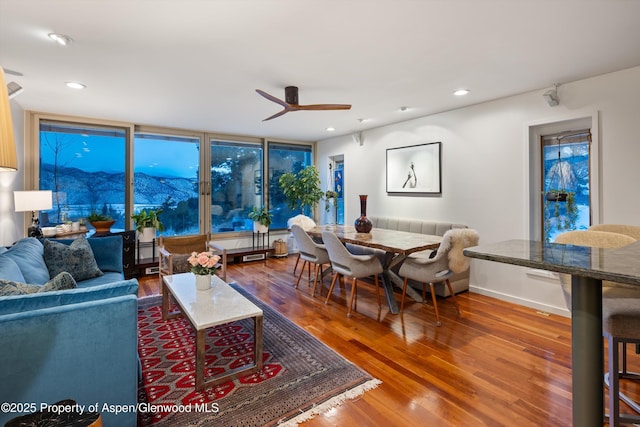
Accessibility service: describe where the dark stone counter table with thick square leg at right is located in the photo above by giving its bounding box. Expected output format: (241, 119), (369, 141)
(464, 240), (640, 427)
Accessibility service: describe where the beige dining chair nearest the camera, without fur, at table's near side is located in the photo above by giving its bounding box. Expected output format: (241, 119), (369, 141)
(322, 231), (383, 317)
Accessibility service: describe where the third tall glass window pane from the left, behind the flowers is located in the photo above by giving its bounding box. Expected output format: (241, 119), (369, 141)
(210, 140), (263, 232)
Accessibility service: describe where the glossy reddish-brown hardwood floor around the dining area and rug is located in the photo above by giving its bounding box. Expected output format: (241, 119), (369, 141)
(140, 256), (640, 427)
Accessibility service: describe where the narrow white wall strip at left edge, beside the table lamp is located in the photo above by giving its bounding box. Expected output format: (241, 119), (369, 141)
(0, 100), (27, 246)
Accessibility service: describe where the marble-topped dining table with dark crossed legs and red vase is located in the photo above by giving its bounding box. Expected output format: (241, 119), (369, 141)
(307, 224), (442, 314)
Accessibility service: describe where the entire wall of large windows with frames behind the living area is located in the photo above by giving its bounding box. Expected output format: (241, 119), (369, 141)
(30, 112), (313, 237)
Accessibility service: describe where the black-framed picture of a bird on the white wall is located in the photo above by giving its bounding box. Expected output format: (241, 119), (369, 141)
(387, 142), (442, 195)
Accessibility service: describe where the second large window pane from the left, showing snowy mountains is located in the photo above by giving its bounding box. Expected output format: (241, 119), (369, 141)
(133, 132), (200, 236)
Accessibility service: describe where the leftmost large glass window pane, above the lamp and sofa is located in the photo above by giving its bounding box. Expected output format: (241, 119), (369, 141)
(38, 120), (127, 230)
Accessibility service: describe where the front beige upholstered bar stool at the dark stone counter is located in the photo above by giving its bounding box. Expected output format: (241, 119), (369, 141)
(555, 230), (640, 426)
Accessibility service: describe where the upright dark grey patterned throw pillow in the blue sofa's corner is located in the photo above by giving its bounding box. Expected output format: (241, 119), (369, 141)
(44, 236), (104, 282)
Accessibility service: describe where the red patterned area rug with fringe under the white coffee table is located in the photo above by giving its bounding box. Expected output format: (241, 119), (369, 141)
(138, 285), (380, 427)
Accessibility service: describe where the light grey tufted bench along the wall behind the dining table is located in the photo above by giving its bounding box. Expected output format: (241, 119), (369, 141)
(356, 217), (469, 297)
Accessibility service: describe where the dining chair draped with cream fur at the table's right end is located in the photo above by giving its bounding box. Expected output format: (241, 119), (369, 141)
(398, 228), (480, 326)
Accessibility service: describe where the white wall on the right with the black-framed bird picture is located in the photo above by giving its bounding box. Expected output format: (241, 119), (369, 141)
(317, 67), (640, 315)
